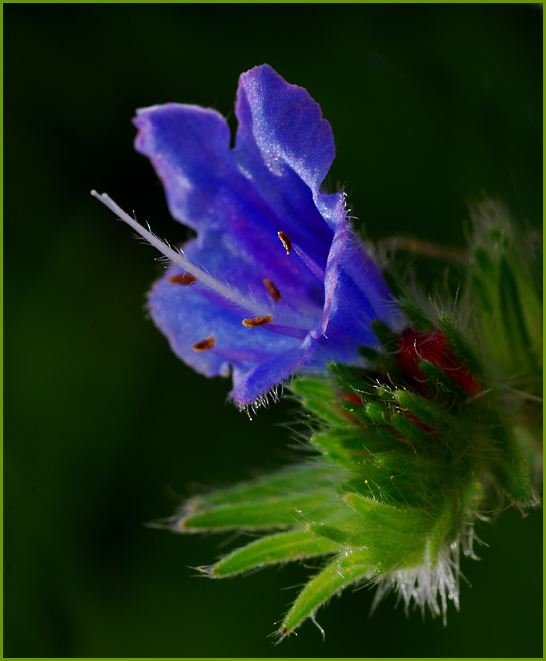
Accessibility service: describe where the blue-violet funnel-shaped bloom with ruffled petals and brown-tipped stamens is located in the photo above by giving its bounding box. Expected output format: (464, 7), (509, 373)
(134, 65), (396, 405)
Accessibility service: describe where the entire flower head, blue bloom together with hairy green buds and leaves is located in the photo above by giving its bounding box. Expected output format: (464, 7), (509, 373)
(93, 65), (542, 638)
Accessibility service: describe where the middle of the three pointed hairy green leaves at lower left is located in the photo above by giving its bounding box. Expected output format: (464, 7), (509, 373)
(207, 530), (339, 578)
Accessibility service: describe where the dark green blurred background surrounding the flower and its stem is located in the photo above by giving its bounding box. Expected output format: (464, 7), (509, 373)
(4, 4), (542, 657)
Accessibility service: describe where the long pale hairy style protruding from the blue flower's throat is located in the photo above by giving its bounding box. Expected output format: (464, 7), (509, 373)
(91, 190), (272, 317)
